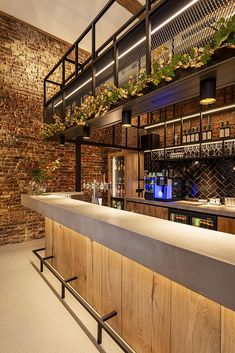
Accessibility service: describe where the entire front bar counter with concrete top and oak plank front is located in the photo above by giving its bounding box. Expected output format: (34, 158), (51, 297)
(22, 195), (235, 353)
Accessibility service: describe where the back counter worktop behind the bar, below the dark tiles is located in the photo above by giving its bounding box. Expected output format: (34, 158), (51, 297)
(125, 197), (235, 218)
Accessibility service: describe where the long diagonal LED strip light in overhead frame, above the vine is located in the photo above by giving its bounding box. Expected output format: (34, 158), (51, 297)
(54, 0), (199, 108)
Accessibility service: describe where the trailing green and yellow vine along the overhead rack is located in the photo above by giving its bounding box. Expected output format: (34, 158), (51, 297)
(43, 15), (235, 138)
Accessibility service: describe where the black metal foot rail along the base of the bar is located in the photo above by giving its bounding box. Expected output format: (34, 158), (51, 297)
(33, 248), (135, 353)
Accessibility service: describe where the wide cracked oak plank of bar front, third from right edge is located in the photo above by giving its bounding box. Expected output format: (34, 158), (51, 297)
(122, 257), (171, 353)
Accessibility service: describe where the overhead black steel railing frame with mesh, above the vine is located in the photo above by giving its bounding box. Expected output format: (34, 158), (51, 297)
(44, 0), (234, 122)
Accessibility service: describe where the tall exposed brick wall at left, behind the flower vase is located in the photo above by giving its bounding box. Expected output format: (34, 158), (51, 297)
(0, 13), (90, 245)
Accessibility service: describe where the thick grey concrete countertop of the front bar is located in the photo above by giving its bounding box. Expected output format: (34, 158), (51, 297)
(21, 195), (235, 310)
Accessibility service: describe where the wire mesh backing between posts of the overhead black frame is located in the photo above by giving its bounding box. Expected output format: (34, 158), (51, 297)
(46, 0), (234, 124)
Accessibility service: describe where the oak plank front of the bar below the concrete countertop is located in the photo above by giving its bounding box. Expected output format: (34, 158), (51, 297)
(45, 218), (235, 353)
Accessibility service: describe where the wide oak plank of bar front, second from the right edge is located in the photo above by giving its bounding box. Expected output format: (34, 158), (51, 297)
(171, 282), (220, 353)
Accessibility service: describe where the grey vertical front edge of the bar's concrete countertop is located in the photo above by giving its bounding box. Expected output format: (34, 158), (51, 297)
(21, 195), (235, 311)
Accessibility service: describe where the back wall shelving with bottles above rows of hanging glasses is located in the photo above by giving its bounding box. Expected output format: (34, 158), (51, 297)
(145, 100), (235, 160)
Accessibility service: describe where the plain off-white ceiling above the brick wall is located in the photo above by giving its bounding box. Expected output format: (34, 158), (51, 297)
(0, 0), (136, 52)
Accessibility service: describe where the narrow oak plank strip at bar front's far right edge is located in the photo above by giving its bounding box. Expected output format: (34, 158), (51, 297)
(221, 306), (235, 353)
